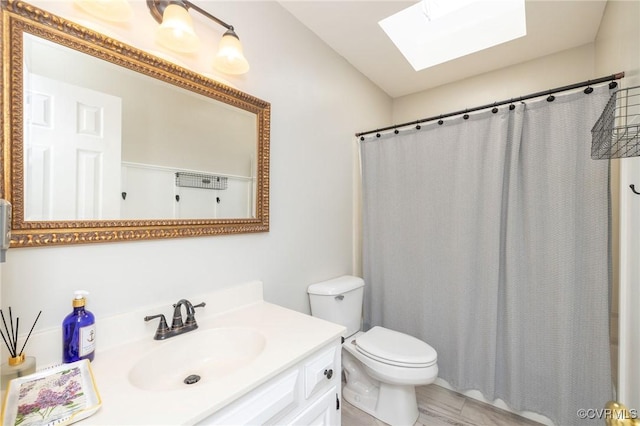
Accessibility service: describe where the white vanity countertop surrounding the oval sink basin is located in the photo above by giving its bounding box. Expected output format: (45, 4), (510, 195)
(86, 301), (344, 425)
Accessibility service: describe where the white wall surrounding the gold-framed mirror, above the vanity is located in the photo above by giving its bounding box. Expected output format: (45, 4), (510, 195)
(1, 0), (391, 351)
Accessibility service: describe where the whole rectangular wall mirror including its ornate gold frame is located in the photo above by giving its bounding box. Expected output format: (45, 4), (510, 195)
(0, 0), (271, 247)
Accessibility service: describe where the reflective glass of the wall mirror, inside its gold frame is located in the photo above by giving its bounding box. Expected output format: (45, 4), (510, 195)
(23, 34), (258, 221)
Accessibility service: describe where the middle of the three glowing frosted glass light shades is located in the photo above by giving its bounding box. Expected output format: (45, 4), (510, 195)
(156, 4), (200, 53)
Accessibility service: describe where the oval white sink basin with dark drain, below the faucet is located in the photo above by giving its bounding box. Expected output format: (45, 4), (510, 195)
(129, 328), (266, 391)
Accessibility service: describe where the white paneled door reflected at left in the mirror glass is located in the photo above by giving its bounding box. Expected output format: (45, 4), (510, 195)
(24, 74), (122, 221)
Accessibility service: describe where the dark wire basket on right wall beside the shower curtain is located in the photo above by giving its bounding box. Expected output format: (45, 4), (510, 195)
(591, 86), (640, 160)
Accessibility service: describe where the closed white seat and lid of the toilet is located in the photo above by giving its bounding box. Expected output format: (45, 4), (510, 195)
(355, 327), (438, 368)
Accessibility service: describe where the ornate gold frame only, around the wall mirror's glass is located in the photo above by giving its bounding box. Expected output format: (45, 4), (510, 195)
(0, 0), (271, 247)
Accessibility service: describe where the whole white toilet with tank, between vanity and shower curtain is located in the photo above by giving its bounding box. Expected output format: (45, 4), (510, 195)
(307, 275), (438, 426)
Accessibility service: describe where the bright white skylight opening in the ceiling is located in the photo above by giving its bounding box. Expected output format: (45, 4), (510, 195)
(378, 0), (527, 71)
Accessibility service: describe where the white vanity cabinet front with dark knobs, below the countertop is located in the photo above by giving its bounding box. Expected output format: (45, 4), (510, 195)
(198, 340), (342, 426)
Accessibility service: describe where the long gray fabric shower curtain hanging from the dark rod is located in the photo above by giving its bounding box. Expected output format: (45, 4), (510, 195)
(360, 86), (612, 425)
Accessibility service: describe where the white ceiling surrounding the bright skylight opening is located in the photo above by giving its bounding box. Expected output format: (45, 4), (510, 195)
(280, 0), (606, 98)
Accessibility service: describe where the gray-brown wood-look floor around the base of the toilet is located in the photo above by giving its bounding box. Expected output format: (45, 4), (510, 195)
(342, 385), (540, 426)
